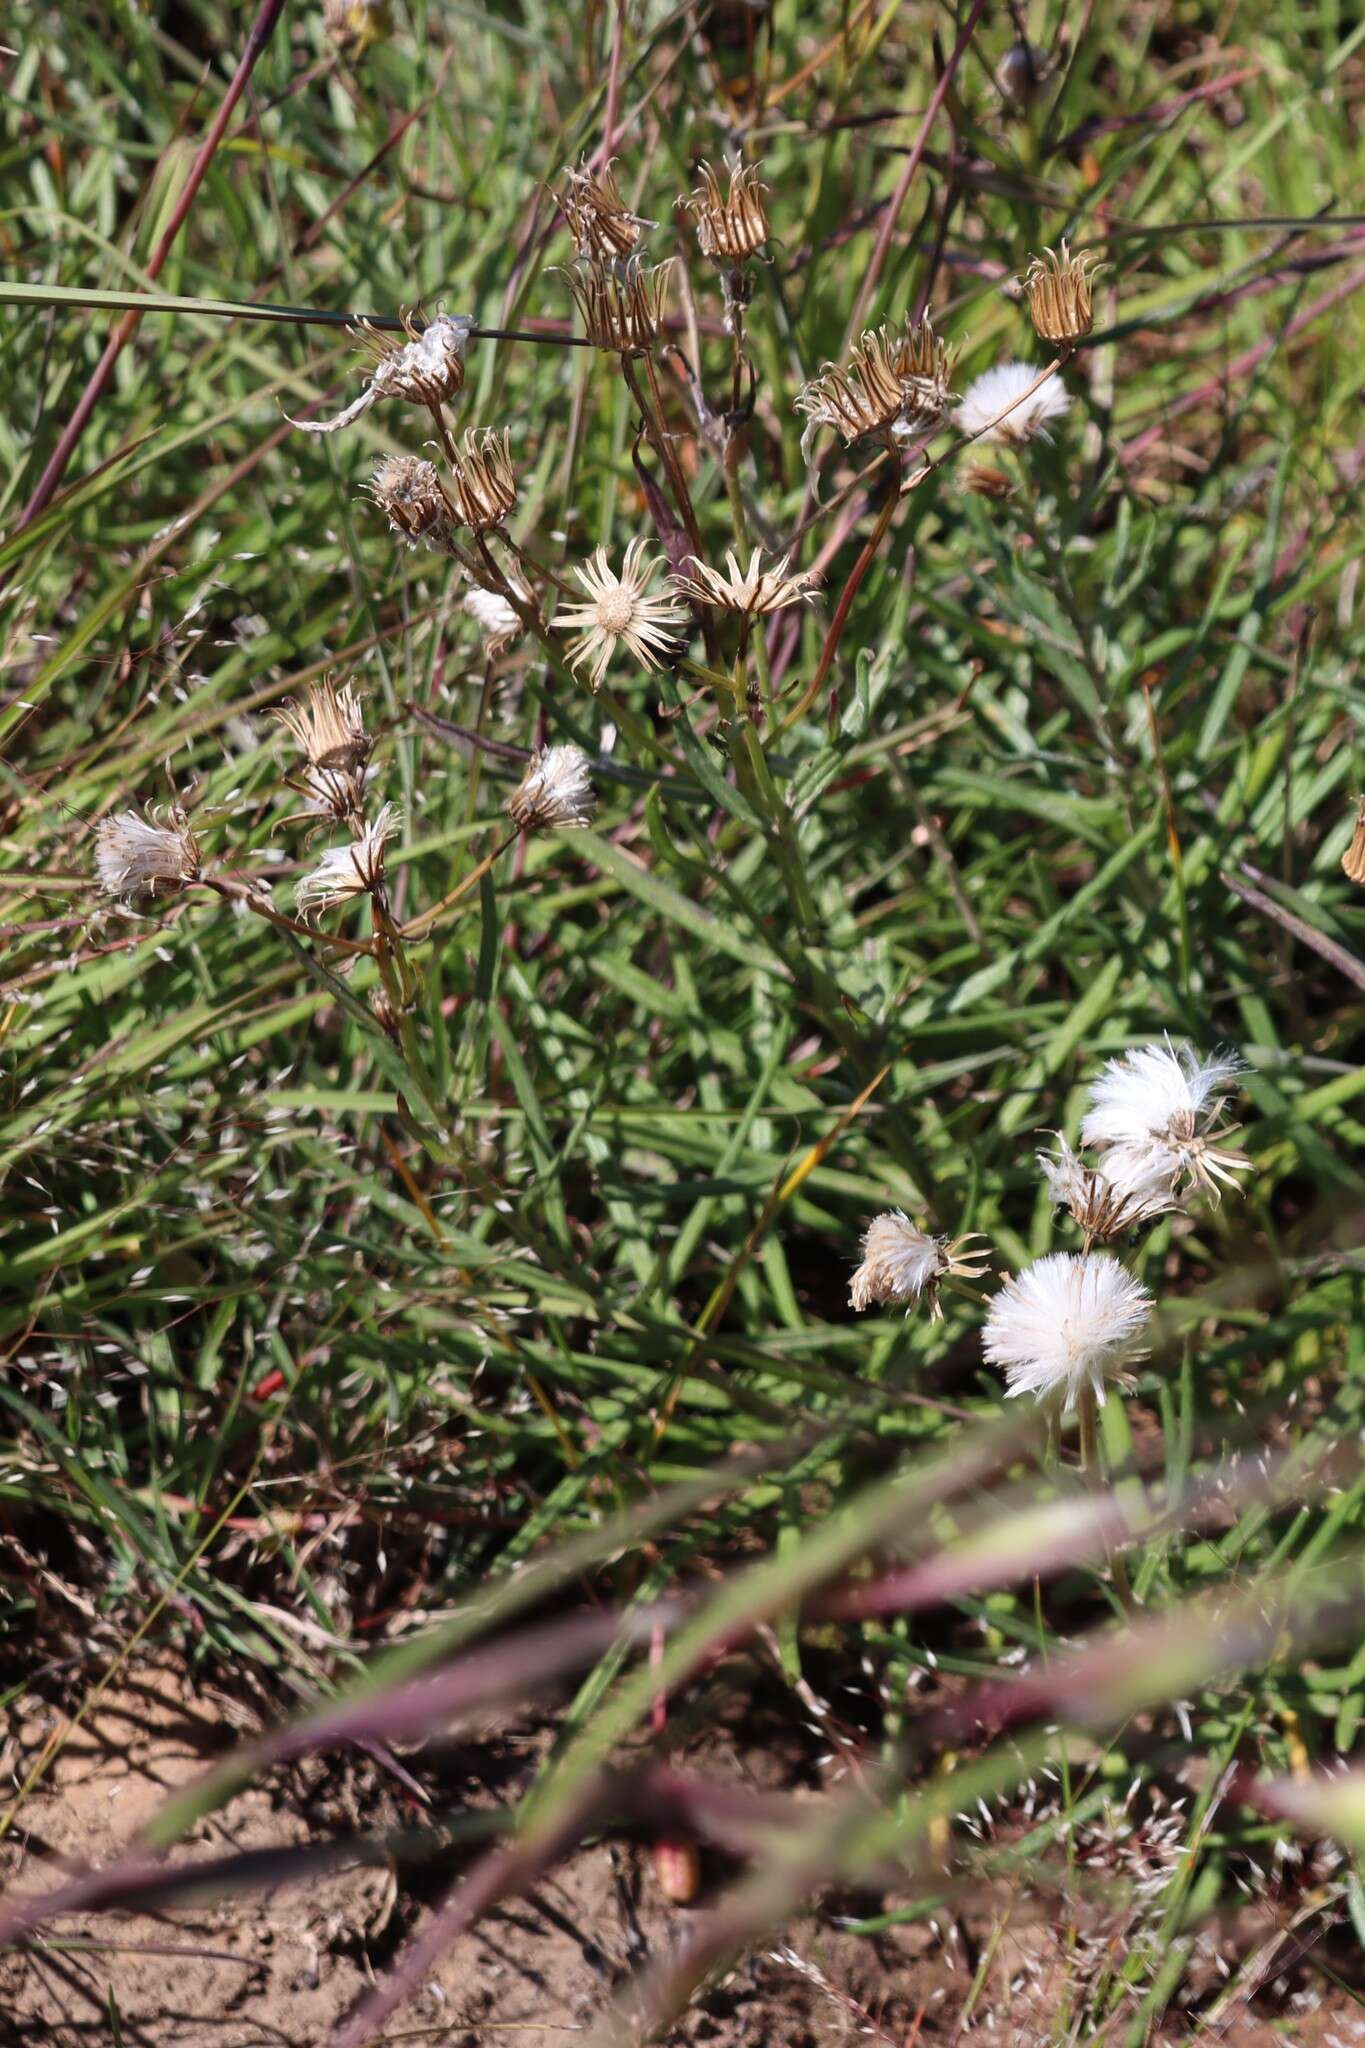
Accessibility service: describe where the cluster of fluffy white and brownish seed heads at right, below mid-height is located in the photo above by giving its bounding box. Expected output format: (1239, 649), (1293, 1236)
(849, 1040), (1248, 1468)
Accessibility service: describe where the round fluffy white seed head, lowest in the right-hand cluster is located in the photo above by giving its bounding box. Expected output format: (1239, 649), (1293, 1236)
(982, 1251), (1152, 1413)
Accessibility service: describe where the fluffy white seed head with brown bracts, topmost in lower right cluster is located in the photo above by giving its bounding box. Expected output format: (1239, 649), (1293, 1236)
(1081, 1038), (1250, 1200)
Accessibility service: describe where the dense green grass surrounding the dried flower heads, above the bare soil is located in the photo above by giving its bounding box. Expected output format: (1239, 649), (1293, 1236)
(0, 0), (1365, 2040)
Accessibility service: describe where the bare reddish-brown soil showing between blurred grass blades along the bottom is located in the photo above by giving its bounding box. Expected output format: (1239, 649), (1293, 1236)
(0, 1659), (1365, 2048)
